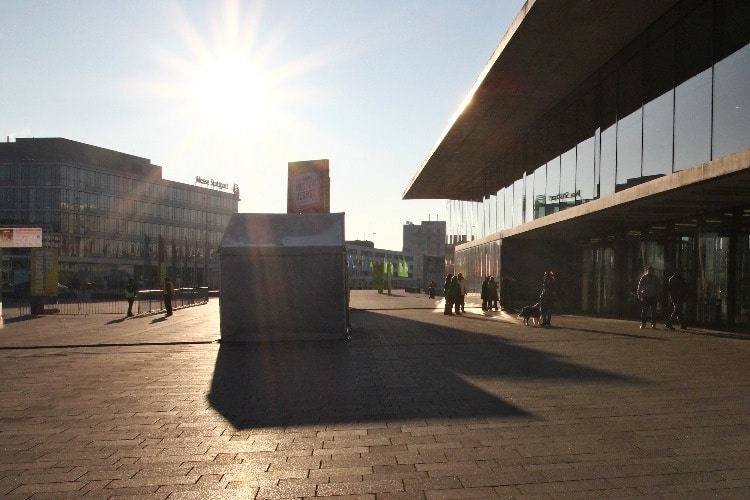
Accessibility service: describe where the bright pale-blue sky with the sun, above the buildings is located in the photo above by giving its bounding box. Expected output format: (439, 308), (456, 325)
(0, 0), (524, 250)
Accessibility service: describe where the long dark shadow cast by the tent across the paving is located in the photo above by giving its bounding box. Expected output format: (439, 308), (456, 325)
(208, 311), (643, 429)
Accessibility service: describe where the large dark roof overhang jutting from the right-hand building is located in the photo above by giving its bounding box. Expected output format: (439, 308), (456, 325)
(403, 0), (677, 201)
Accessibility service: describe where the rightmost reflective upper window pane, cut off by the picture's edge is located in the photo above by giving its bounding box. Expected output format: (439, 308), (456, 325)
(713, 45), (750, 158)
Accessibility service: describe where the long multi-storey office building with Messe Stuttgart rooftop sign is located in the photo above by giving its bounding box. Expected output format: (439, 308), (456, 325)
(0, 138), (239, 290)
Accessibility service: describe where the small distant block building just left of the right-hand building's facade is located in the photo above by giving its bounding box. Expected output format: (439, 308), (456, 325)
(404, 221), (447, 290)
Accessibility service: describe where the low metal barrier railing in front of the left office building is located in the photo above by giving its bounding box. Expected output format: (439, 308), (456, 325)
(2, 288), (208, 319)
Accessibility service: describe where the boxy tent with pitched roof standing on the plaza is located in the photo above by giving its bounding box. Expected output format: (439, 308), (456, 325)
(219, 213), (349, 342)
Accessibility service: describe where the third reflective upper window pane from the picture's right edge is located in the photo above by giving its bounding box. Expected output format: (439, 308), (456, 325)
(643, 91), (674, 177)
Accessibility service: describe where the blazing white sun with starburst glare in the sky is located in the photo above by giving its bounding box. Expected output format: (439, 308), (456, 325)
(141, 0), (314, 141)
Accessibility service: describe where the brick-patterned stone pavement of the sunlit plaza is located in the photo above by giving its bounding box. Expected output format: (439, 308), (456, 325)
(0, 291), (750, 500)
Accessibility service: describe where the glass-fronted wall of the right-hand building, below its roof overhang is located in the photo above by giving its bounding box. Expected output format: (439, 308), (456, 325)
(412, 0), (750, 326)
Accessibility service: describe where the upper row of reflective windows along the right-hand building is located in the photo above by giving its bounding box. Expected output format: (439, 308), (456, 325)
(449, 10), (750, 236)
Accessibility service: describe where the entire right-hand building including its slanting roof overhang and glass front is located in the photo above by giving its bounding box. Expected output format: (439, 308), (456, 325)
(404, 0), (750, 326)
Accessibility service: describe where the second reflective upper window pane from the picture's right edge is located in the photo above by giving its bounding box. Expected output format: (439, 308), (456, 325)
(674, 69), (711, 172)
